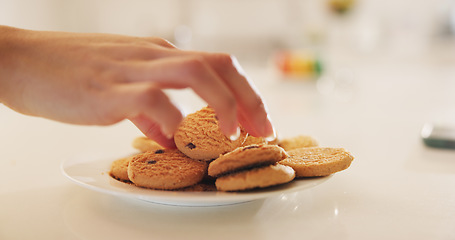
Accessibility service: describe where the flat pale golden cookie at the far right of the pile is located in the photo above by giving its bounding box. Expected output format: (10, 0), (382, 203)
(279, 147), (354, 177)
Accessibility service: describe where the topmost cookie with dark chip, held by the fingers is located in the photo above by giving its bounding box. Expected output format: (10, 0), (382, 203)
(174, 107), (247, 161)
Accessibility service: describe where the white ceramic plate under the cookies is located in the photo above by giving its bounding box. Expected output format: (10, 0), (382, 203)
(61, 156), (330, 206)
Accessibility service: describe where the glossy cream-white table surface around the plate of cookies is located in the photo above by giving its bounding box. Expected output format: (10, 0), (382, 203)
(0, 49), (455, 239)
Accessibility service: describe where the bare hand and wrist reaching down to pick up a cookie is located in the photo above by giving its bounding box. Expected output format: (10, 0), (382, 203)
(0, 26), (275, 147)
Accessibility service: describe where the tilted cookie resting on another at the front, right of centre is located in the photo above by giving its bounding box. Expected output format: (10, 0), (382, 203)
(208, 144), (288, 177)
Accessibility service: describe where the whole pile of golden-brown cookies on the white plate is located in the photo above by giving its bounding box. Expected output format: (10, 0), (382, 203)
(110, 107), (353, 191)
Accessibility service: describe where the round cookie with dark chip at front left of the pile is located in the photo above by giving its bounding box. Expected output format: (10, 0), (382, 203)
(128, 149), (207, 190)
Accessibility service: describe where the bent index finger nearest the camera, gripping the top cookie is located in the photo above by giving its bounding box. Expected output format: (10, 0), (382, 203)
(121, 56), (242, 138)
